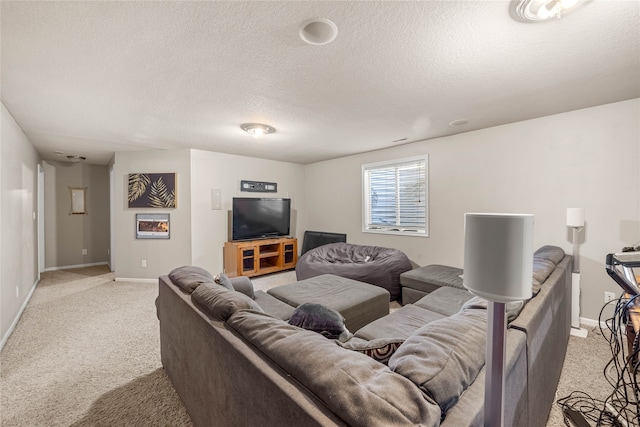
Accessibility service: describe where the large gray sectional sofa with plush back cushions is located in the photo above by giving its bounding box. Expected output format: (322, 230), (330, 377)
(156, 247), (571, 427)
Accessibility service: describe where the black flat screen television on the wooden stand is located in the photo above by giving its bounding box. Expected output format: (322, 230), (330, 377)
(231, 197), (291, 241)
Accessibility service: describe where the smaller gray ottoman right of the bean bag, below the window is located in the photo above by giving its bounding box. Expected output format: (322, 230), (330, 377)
(400, 264), (464, 304)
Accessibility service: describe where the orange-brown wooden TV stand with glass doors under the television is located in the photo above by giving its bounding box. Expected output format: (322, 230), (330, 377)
(224, 237), (298, 277)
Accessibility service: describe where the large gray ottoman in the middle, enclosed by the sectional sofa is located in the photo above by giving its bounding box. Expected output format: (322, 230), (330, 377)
(267, 274), (389, 332)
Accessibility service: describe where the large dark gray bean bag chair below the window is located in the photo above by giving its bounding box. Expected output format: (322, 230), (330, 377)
(296, 243), (412, 301)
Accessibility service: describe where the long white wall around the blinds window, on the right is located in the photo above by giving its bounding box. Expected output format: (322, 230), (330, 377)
(305, 99), (640, 319)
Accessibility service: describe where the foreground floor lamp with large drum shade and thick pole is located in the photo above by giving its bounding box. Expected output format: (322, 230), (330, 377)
(463, 213), (533, 427)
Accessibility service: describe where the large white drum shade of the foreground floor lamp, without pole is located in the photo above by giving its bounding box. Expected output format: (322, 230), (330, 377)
(464, 213), (533, 302)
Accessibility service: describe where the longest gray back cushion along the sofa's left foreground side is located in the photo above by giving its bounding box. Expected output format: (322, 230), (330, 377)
(227, 310), (441, 427)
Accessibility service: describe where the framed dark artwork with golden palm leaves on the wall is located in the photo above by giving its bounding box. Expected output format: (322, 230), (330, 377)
(127, 173), (177, 209)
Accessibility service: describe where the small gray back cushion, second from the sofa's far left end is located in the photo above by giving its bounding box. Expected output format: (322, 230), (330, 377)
(191, 283), (263, 322)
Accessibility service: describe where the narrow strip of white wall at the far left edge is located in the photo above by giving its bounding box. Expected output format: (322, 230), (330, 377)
(0, 104), (40, 348)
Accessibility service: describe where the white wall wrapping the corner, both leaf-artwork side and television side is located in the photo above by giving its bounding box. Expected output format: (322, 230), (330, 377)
(114, 150), (304, 279)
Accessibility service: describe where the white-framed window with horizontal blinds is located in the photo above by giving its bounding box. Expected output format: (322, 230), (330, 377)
(362, 155), (429, 237)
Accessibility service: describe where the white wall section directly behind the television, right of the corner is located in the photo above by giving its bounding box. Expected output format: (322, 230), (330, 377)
(191, 150), (304, 274)
